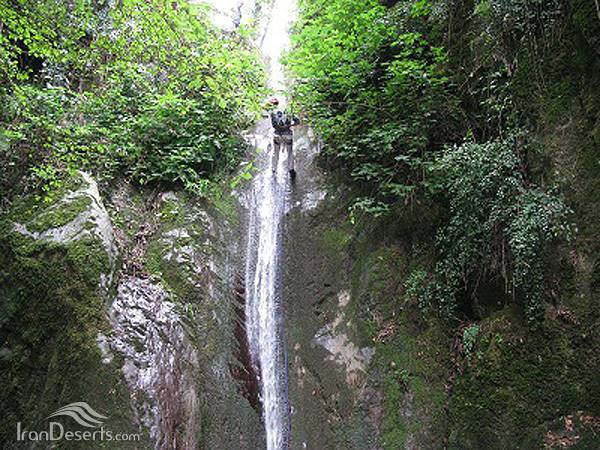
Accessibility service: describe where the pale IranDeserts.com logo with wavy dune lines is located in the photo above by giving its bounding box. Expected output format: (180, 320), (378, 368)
(17, 402), (140, 442)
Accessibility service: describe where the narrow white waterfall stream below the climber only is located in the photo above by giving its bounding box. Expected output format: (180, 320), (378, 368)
(246, 128), (289, 450)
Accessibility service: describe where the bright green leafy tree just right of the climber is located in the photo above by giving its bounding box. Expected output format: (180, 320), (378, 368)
(287, 0), (458, 214)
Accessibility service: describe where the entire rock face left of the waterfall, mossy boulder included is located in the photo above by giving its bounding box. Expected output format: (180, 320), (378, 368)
(0, 174), (263, 449)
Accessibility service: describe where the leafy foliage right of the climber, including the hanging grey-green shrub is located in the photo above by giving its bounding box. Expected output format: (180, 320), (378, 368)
(287, 0), (569, 322)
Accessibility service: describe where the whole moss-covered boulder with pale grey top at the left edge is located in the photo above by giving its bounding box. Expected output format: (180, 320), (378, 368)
(0, 173), (145, 448)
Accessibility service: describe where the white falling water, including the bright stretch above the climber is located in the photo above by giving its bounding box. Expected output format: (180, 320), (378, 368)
(246, 0), (294, 450)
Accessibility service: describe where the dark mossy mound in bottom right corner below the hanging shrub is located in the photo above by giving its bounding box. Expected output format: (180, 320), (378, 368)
(449, 309), (600, 449)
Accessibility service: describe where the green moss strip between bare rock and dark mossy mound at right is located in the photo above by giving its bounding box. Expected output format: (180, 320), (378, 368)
(351, 240), (449, 449)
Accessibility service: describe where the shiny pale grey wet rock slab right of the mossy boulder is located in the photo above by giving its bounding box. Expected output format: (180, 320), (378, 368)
(99, 277), (200, 448)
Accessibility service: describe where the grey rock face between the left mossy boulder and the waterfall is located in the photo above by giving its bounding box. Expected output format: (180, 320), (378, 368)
(105, 185), (262, 449)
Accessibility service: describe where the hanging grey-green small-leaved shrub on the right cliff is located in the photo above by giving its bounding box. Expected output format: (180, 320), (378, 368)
(421, 138), (570, 322)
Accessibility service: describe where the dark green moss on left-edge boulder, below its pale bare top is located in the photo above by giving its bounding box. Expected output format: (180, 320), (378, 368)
(0, 207), (142, 448)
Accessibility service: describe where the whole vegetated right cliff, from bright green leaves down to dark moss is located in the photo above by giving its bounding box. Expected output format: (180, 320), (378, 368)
(286, 0), (600, 448)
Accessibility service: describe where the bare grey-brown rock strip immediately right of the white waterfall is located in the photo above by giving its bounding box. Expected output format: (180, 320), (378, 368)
(283, 124), (381, 449)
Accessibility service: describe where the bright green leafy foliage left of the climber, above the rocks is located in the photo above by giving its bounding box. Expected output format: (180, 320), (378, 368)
(0, 0), (264, 200)
